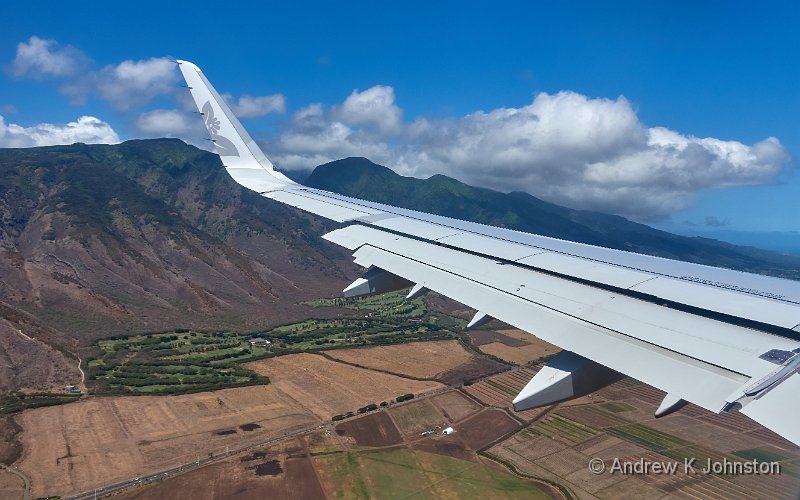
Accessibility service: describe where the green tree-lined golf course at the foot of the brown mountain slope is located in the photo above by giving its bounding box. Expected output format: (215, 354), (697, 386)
(87, 291), (461, 394)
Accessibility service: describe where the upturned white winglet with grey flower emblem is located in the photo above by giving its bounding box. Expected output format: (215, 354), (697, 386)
(177, 60), (296, 193)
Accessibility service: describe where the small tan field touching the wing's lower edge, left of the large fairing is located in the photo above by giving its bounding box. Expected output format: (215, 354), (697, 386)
(467, 329), (561, 365)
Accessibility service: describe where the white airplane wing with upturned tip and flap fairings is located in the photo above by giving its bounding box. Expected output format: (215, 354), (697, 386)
(178, 61), (800, 444)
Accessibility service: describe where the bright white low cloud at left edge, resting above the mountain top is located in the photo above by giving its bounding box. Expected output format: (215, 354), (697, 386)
(0, 116), (119, 148)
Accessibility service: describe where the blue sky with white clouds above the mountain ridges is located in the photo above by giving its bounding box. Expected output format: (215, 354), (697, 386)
(0, 1), (800, 240)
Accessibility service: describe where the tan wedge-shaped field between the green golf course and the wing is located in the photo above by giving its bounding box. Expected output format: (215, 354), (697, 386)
(326, 340), (475, 379)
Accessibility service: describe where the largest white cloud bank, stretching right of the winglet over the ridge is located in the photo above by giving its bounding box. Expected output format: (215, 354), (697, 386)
(266, 86), (790, 220)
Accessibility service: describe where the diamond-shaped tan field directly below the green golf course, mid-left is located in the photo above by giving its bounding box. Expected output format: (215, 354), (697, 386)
(244, 353), (444, 420)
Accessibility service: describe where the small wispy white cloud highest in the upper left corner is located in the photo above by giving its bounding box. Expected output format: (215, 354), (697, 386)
(8, 36), (89, 79)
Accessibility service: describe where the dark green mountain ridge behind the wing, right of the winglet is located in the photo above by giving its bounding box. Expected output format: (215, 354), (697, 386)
(306, 158), (800, 279)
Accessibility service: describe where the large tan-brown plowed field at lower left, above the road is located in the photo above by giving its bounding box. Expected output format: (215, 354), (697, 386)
(18, 385), (316, 497)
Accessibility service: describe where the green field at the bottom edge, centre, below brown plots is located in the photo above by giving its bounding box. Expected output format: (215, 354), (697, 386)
(315, 449), (550, 499)
